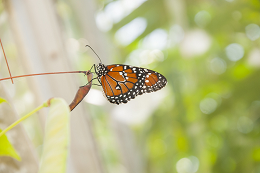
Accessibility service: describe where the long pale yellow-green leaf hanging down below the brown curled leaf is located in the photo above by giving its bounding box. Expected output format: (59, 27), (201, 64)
(39, 98), (70, 173)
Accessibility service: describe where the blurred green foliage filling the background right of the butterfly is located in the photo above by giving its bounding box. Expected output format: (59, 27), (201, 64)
(93, 0), (260, 173)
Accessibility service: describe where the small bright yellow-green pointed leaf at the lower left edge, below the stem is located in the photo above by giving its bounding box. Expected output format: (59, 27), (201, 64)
(0, 129), (21, 161)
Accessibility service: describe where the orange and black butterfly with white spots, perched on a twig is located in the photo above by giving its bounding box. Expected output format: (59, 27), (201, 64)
(88, 46), (167, 105)
